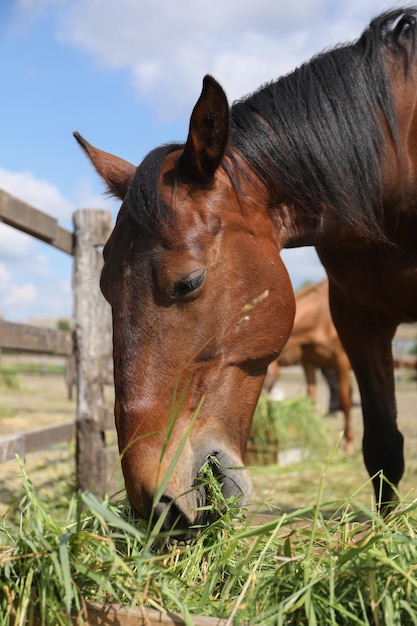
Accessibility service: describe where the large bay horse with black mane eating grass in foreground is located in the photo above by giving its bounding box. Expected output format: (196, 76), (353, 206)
(76, 8), (417, 528)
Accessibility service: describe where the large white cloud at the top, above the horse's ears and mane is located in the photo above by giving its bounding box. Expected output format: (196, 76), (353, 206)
(54, 0), (392, 116)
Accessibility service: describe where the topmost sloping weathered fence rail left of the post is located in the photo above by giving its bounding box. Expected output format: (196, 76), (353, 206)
(0, 189), (73, 255)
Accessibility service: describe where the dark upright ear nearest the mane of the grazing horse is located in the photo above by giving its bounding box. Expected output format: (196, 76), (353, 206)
(180, 75), (230, 182)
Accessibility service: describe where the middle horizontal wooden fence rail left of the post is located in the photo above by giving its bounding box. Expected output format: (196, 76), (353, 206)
(0, 320), (73, 356)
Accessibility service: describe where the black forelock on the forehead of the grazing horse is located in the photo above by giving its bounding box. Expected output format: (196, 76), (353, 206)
(126, 143), (183, 233)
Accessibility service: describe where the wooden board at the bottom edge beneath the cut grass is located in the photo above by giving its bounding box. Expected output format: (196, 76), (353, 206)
(81, 604), (226, 626)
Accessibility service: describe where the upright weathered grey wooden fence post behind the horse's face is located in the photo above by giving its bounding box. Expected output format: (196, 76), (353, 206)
(73, 209), (112, 497)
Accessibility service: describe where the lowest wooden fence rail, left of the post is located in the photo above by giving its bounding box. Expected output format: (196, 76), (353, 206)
(0, 420), (75, 463)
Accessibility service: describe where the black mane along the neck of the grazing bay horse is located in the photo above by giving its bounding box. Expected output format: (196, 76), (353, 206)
(229, 8), (417, 237)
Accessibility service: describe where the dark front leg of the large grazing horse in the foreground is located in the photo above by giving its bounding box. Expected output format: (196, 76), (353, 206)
(329, 281), (404, 505)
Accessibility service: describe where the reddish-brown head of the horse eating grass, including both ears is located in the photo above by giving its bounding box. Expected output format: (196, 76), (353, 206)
(76, 77), (294, 530)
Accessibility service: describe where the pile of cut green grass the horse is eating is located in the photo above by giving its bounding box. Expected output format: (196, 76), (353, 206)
(0, 456), (417, 626)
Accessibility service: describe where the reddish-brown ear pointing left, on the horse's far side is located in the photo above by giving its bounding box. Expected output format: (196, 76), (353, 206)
(73, 132), (136, 200)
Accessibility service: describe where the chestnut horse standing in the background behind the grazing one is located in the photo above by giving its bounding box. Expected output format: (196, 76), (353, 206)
(264, 280), (353, 452)
